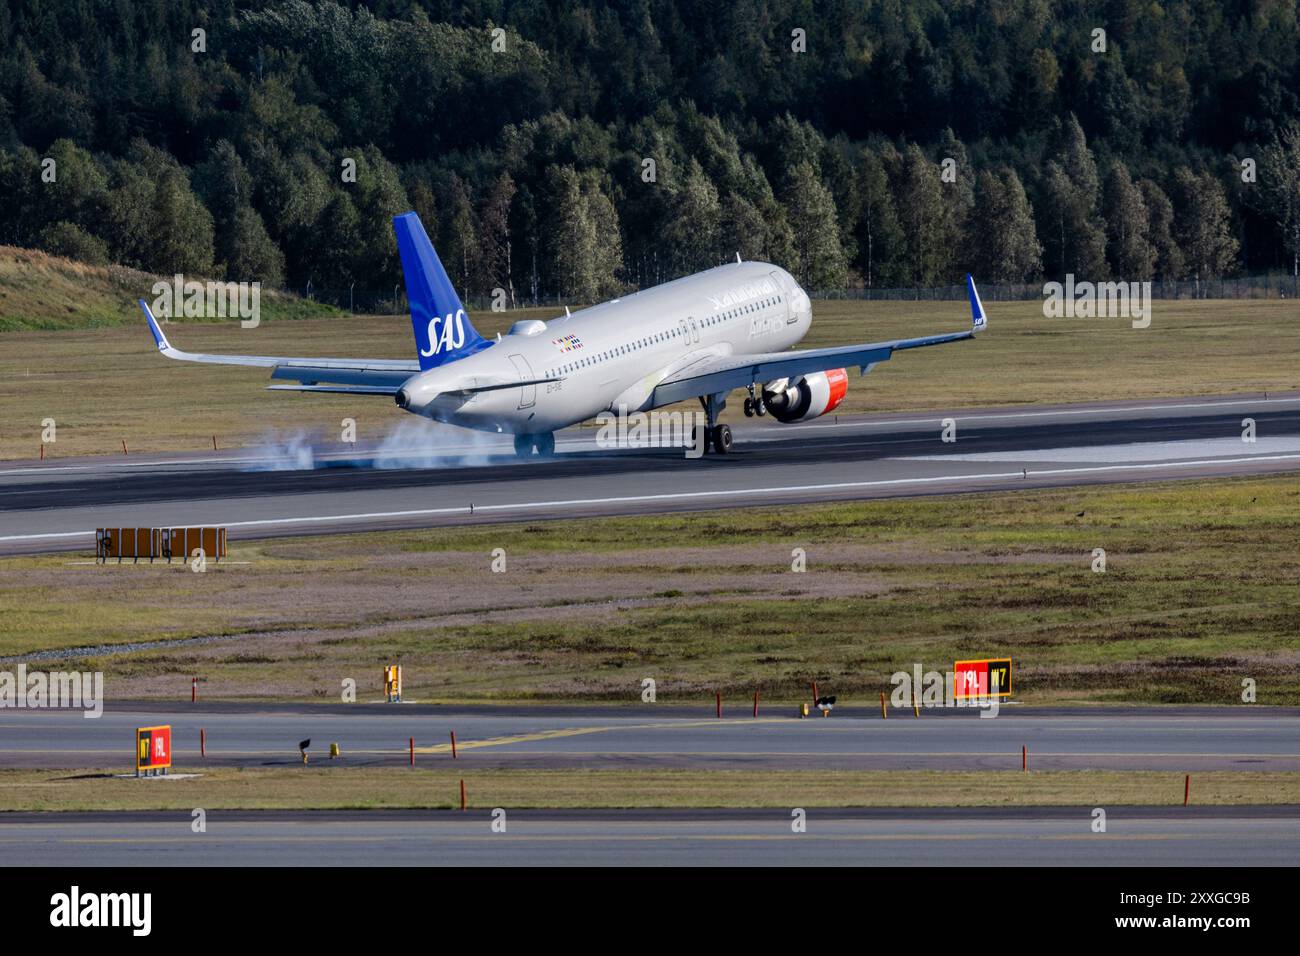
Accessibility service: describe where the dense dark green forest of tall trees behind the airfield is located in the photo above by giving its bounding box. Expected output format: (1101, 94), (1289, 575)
(0, 0), (1300, 304)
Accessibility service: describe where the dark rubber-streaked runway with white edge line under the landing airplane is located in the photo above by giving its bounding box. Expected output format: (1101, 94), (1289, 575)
(0, 393), (1300, 554)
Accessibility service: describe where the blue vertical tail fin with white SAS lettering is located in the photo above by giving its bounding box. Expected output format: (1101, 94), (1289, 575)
(393, 212), (491, 371)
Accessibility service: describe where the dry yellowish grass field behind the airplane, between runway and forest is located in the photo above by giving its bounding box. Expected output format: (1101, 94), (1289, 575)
(0, 280), (1300, 458)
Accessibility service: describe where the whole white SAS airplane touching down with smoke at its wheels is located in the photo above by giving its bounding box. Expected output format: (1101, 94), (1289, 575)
(140, 212), (988, 458)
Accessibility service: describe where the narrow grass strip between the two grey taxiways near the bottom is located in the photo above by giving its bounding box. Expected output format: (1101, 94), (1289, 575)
(0, 754), (1300, 812)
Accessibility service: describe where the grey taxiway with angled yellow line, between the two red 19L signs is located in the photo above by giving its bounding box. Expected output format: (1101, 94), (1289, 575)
(0, 702), (1300, 773)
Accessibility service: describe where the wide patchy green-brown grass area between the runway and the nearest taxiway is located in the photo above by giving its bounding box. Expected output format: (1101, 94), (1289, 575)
(0, 476), (1300, 705)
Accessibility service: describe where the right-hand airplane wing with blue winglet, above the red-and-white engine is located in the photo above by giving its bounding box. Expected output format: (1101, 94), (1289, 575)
(653, 276), (988, 406)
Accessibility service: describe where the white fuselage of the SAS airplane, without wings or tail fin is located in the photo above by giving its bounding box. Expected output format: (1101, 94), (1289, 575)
(402, 263), (813, 434)
